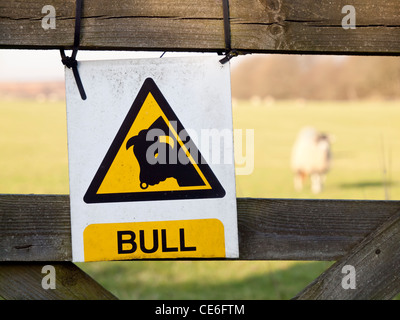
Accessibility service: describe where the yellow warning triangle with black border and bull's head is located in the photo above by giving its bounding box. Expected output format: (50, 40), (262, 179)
(84, 78), (225, 203)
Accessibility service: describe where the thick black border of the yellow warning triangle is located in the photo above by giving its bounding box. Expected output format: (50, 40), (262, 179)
(83, 78), (226, 204)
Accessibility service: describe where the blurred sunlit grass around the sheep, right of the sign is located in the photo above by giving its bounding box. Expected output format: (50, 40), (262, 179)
(233, 101), (400, 200)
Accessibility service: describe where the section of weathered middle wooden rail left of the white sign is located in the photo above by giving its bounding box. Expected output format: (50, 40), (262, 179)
(0, 195), (72, 261)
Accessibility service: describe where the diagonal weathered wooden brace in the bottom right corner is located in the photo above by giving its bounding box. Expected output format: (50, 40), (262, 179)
(296, 211), (400, 300)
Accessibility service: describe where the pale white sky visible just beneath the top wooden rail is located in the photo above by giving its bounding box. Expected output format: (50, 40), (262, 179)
(0, 49), (243, 82)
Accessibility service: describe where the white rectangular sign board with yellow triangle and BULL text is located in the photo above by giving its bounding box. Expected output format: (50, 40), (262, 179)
(66, 56), (238, 261)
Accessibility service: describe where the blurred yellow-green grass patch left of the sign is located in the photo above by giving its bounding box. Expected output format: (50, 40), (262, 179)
(0, 101), (69, 194)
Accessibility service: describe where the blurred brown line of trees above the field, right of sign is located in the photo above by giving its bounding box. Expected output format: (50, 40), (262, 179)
(232, 55), (400, 100)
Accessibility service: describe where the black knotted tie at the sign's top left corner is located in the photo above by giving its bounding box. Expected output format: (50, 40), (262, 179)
(60, 0), (86, 100)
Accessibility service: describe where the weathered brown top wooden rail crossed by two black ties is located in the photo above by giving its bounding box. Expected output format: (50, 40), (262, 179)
(0, 0), (400, 55)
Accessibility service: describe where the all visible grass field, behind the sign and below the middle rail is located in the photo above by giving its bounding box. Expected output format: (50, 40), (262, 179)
(0, 101), (400, 299)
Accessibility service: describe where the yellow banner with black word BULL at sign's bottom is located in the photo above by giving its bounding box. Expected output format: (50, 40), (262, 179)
(83, 219), (225, 261)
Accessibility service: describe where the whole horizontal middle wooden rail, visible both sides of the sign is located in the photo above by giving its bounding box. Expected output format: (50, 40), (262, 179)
(0, 194), (400, 261)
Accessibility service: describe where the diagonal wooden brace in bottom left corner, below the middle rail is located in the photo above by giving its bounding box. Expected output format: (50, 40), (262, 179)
(0, 262), (117, 300)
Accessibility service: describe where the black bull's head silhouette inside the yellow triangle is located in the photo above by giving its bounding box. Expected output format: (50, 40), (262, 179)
(126, 117), (205, 189)
